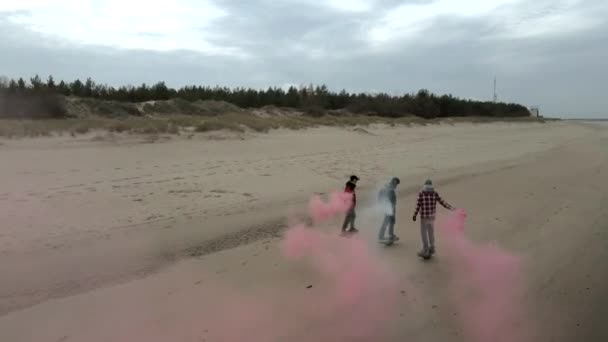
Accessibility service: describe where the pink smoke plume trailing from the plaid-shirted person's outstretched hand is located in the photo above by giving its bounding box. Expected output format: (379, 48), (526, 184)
(441, 210), (529, 342)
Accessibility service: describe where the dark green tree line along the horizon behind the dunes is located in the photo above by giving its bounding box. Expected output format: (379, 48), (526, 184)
(0, 75), (530, 119)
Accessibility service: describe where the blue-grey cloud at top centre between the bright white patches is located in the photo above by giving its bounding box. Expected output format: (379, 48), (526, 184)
(205, 0), (376, 57)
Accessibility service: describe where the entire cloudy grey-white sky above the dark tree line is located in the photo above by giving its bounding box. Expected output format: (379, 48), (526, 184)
(0, 0), (608, 117)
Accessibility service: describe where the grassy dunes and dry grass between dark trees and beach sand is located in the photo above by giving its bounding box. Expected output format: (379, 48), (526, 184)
(0, 97), (544, 138)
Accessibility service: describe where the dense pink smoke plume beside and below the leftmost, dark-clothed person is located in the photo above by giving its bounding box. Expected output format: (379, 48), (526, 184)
(282, 192), (398, 342)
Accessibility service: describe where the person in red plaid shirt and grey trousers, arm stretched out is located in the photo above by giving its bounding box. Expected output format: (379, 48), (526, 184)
(412, 179), (454, 257)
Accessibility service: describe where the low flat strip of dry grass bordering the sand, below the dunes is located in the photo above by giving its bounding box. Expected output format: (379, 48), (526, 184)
(0, 111), (545, 138)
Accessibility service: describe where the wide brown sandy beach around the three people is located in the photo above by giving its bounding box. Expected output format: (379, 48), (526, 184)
(0, 122), (608, 342)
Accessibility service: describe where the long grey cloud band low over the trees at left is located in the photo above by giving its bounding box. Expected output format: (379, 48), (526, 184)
(0, 17), (252, 86)
